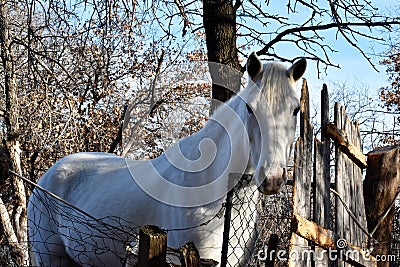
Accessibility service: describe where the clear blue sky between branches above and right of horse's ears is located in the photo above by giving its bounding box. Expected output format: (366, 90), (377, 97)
(233, 0), (400, 102)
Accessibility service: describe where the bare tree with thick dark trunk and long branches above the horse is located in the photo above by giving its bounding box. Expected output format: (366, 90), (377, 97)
(196, 0), (400, 107)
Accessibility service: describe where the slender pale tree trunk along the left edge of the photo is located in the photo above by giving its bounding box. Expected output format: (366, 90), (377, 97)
(0, 0), (29, 265)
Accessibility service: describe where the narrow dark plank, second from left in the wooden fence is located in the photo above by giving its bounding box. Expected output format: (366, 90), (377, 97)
(312, 84), (331, 267)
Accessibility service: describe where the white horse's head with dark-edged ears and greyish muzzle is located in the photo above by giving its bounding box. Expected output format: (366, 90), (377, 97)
(246, 53), (307, 194)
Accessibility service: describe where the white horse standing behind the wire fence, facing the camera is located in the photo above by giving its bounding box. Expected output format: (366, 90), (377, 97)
(28, 53), (306, 266)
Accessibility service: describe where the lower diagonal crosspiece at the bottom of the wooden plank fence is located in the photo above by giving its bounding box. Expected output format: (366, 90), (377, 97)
(292, 214), (377, 267)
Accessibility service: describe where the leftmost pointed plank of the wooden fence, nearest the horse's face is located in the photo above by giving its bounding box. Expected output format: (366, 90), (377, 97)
(289, 79), (314, 266)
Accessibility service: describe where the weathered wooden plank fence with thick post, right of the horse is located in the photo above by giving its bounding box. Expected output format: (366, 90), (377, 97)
(289, 80), (400, 266)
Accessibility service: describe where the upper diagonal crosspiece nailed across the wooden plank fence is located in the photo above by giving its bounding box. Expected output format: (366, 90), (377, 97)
(325, 123), (367, 169)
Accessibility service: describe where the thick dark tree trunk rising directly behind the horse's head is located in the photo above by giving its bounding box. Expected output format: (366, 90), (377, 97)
(203, 0), (242, 112)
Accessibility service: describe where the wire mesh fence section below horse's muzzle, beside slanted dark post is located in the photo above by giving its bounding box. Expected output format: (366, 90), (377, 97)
(222, 176), (292, 267)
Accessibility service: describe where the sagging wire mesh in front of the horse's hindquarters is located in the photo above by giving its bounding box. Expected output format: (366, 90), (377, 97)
(29, 191), (139, 266)
